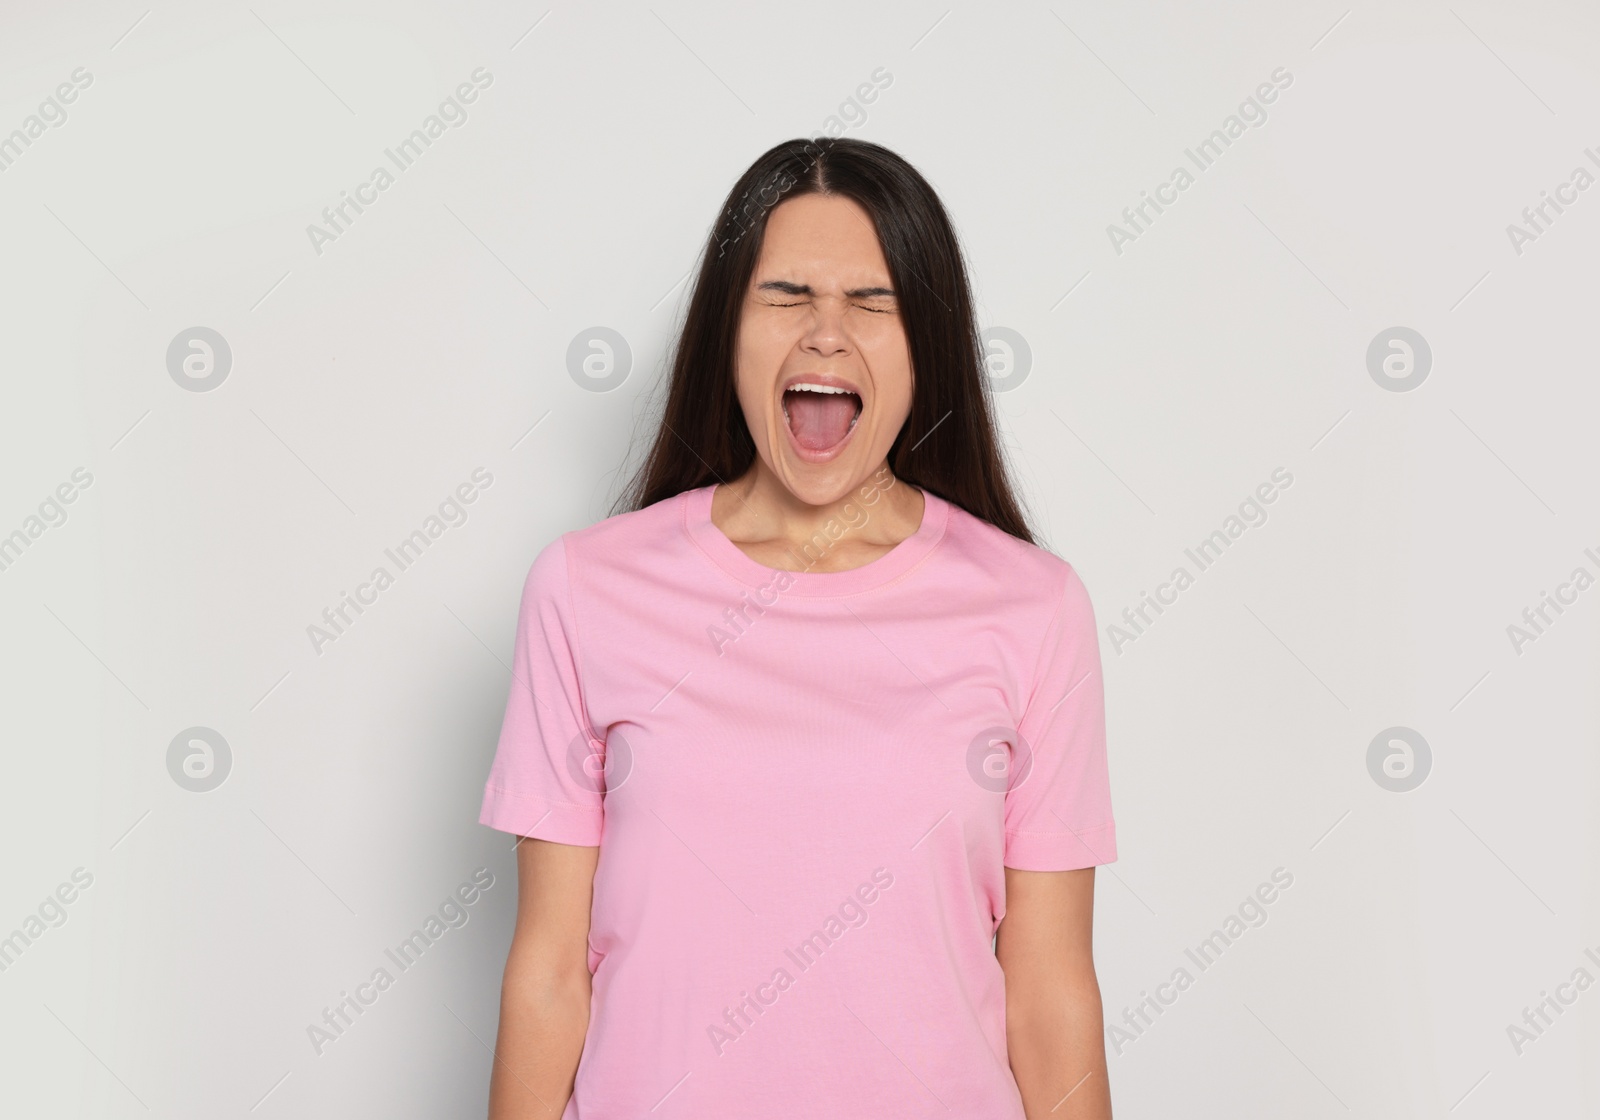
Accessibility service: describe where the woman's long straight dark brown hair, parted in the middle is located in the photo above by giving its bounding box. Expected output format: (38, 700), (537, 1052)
(618, 138), (1037, 544)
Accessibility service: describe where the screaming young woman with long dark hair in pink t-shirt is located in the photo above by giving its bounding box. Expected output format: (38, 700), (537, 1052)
(480, 139), (1115, 1120)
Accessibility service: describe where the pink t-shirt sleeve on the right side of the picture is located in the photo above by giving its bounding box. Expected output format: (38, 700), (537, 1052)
(1003, 565), (1117, 870)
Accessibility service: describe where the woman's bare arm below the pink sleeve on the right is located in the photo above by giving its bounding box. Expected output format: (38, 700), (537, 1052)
(995, 867), (1110, 1120)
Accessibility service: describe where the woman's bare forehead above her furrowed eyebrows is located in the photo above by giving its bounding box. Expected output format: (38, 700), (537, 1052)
(752, 194), (888, 283)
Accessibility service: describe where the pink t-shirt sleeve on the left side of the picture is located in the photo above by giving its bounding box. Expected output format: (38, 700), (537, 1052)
(478, 538), (605, 846)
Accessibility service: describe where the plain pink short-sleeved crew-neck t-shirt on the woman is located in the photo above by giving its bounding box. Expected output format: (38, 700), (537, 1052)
(478, 483), (1117, 1120)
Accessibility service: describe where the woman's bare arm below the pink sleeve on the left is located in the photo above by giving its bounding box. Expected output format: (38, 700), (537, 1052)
(490, 838), (600, 1120)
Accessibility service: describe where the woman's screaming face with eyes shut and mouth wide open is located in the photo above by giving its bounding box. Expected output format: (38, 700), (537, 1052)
(736, 194), (912, 506)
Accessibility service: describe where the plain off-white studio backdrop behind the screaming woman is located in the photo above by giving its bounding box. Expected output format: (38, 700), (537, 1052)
(0, 0), (1600, 1120)
